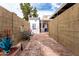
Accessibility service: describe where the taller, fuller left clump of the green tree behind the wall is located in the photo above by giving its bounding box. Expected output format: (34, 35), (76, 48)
(20, 3), (32, 21)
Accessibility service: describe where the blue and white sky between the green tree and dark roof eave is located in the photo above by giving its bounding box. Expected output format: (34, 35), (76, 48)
(31, 3), (61, 18)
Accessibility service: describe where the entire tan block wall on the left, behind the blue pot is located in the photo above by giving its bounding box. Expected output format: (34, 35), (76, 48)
(0, 6), (29, 44)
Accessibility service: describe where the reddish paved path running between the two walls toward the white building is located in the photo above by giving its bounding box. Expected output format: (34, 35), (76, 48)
(20, 33), (72, 56)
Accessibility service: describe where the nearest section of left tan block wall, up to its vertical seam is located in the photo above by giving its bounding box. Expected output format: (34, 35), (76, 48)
(0, 6), (12, 32)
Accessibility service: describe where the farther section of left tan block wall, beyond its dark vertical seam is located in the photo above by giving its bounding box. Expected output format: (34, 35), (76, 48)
(13, 14), (29, 44)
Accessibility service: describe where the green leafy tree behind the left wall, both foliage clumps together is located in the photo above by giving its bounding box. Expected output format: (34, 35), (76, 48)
(20, 3), (38, 21)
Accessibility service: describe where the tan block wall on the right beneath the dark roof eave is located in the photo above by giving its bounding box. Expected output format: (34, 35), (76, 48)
(49, 4), (79, 55)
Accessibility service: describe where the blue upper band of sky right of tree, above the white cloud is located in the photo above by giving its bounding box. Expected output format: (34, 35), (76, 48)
(32, 3), (60, 11)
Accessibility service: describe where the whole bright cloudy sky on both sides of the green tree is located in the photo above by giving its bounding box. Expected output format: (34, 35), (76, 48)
(0, 3), (61, 18)
